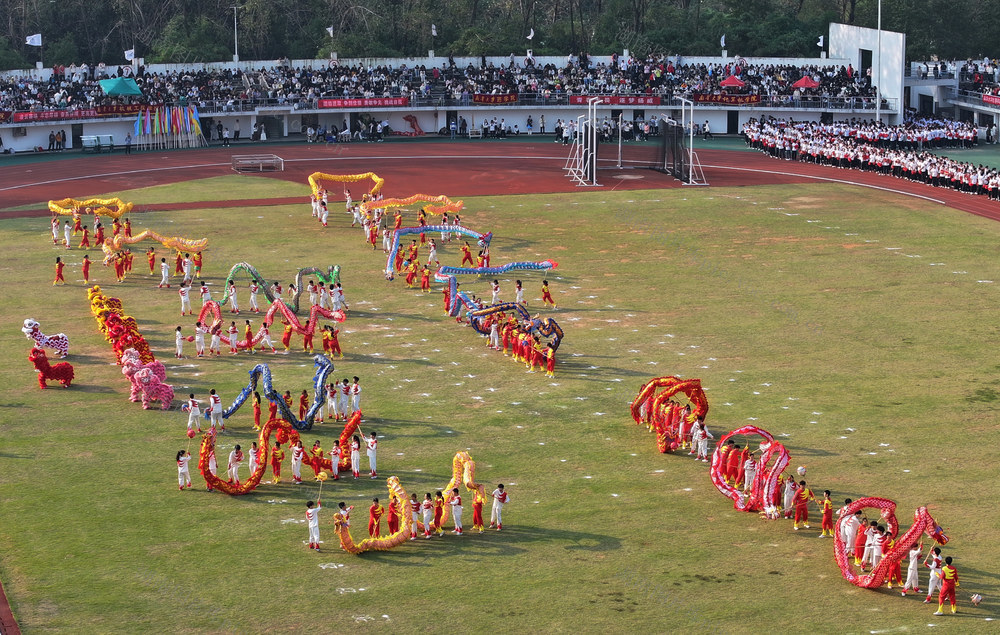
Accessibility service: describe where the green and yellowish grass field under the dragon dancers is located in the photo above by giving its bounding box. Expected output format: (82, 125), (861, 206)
(0, 177), (1000, 632)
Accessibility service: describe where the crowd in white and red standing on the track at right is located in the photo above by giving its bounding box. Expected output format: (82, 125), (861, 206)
(743, 117), (1000, 200)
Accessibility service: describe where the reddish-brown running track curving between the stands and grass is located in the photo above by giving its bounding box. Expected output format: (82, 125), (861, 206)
(0, 139), (1000, 220)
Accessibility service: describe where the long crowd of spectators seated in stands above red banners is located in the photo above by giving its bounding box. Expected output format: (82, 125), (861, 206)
(0, 55), (874, 111)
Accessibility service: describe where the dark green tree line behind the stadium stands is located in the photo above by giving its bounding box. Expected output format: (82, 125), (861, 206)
(0, 0), (1000, 69)
